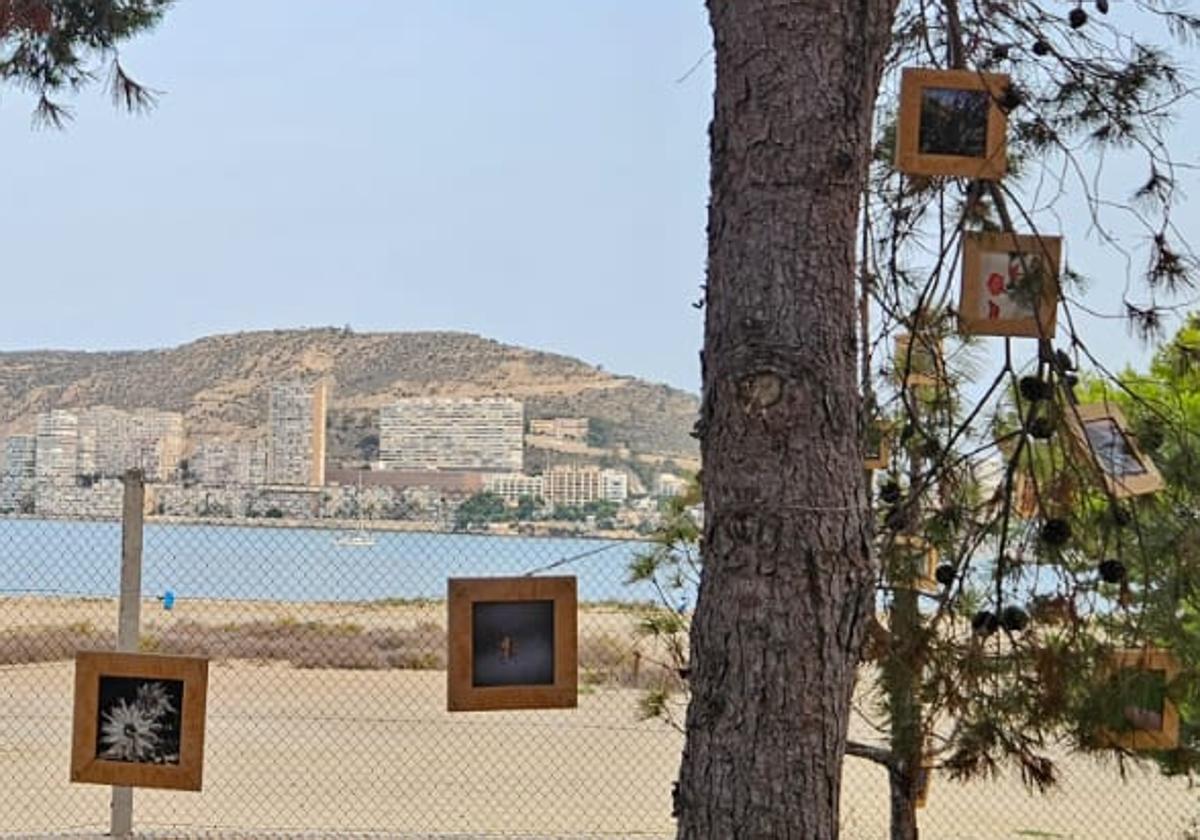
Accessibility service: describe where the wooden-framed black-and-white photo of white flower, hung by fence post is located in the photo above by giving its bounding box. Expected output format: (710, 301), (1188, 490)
(71, 650), (209, 791)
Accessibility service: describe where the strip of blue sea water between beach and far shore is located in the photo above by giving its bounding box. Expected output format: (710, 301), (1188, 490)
(0, 517), (695, 608)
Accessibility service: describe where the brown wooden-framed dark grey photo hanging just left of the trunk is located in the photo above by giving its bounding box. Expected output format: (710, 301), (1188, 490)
(446, 577), (578, 712)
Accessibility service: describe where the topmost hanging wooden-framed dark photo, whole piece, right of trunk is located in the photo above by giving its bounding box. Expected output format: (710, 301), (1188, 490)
(895, 67), (1009, 181)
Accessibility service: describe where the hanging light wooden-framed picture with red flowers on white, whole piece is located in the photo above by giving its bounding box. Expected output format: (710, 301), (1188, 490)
(959, 233), (1062, 338)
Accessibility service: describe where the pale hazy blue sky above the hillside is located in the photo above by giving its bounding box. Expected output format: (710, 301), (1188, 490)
(0, 0), (1200, 391)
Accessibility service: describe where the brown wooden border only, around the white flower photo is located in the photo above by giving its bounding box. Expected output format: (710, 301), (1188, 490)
(71, 650), (209, 791)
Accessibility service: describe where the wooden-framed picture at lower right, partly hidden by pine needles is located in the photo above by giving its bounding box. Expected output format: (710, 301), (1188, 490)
(1100, 648), (1181, 751)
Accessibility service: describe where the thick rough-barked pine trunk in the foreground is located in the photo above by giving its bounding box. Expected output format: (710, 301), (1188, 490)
(677, 0), (894, 840)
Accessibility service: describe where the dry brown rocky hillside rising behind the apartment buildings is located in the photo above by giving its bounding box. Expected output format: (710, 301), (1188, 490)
(0, 329), (697, 461)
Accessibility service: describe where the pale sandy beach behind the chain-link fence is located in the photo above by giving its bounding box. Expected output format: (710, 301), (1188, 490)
(0, 598), (1200, 840)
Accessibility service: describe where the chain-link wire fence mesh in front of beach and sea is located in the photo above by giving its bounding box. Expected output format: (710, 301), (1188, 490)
(0, 482), (1200, 840)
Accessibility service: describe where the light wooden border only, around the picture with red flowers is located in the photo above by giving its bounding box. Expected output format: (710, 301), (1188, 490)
(959, 233), (1062, 338)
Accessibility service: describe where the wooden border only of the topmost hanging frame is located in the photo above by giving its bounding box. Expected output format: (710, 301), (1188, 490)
(895, 67), (1009, 181)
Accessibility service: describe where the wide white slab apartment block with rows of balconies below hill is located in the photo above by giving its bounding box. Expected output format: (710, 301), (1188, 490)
(379, 397), (524, 473)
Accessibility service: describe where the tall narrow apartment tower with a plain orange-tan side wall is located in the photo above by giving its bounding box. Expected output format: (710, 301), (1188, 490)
(266, 380), (328, 487)
